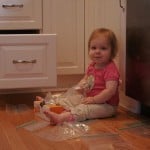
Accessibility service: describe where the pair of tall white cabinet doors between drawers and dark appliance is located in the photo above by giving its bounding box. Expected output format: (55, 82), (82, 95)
(43, 0), (120, 75)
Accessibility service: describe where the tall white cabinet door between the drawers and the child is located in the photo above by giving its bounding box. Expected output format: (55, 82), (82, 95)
(43, 0), (84, 74)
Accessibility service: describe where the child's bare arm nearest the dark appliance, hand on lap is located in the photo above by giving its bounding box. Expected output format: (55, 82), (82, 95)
(83, 81), (118, 104)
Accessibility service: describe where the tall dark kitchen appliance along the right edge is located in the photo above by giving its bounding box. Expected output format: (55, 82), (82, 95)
(125, 0), (150, 116)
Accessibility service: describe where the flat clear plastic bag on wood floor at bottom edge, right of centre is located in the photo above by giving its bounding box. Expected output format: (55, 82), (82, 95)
(81, 133), (136, 150)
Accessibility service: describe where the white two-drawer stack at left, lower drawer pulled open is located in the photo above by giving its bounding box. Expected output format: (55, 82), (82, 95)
(0, 0), (57, 90)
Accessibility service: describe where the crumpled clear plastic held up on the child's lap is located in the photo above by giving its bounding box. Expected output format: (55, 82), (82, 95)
(38, 76), (94, 109)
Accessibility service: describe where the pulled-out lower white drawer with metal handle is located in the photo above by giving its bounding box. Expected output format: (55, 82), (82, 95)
(0, 34), (56, 89)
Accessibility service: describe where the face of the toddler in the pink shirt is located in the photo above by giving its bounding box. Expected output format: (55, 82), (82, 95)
(89, 36), (111, 67)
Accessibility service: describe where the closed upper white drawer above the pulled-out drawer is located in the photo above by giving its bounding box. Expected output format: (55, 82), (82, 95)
(0, 0), (42, 30)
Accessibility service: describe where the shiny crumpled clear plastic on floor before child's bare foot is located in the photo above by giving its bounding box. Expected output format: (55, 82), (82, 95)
(35, 122), (89, 141)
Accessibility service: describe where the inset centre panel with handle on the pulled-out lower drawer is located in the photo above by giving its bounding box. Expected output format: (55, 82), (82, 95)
(1, 44), (46, 75)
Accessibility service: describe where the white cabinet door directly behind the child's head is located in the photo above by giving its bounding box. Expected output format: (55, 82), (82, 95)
(85, 0), (121, 69)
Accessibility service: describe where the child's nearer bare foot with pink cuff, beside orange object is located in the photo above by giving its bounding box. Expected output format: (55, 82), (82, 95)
(44, 111), (74, 125)
